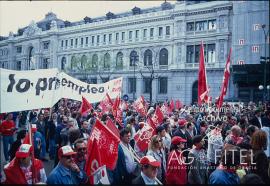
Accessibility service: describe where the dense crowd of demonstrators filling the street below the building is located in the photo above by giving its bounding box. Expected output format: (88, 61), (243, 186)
(0, 99), (270, 185)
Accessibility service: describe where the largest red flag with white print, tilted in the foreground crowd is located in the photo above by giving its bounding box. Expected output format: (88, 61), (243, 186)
(90, 119), (120, 170)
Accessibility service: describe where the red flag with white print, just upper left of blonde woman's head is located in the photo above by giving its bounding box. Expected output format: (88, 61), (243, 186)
(134, 124), (155, 151)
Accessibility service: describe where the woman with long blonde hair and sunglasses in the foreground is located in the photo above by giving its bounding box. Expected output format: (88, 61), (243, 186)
(146, 135), (166, 183)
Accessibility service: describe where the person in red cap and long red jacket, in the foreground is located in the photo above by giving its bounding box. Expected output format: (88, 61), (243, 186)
(166, 136), (187, 185)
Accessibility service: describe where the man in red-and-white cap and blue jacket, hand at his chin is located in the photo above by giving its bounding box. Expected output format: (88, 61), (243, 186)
(47, 145), (88, 184)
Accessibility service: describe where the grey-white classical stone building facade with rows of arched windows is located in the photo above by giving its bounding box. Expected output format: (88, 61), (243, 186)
(0, 1), (269, 104)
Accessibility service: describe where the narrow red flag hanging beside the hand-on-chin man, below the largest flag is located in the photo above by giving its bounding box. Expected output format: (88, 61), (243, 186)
(85, 139), (102, 184)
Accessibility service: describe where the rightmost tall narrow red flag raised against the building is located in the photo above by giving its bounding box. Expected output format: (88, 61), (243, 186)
(217, 49), (232, 108)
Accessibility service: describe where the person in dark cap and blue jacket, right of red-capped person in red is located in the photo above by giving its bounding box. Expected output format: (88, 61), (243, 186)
(188, 135), (208, 184)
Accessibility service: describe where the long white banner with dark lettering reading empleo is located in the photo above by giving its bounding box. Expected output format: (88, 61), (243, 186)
(0, 68), (122, 113)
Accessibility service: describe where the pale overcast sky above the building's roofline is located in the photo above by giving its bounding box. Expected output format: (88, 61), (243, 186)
(0, 0), (174, 36)
